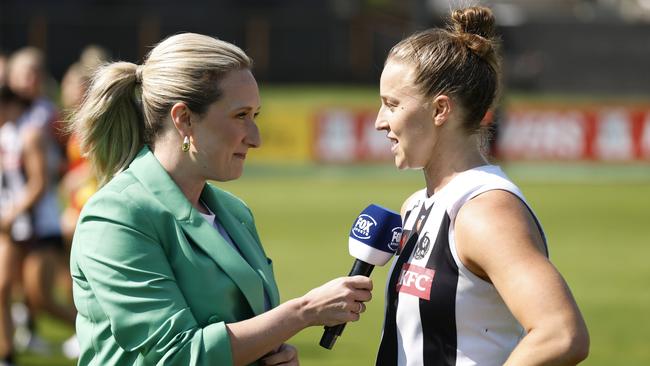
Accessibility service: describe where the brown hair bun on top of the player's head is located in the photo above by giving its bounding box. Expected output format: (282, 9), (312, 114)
(451, 6), (495, 58)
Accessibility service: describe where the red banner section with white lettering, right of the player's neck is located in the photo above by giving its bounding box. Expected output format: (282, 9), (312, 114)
(496, 108), (650, 161)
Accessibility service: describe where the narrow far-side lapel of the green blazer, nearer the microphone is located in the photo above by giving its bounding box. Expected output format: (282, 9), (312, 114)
(201, 184), (280, 307)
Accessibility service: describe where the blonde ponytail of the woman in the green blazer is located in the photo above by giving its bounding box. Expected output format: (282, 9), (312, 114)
(72, 62), (145, 185)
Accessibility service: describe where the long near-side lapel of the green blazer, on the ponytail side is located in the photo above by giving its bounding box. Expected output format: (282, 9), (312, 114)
(129, 146), (264, 315)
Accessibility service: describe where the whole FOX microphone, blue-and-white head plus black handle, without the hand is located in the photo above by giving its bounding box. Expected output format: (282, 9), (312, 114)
(319, 204), (402, 349)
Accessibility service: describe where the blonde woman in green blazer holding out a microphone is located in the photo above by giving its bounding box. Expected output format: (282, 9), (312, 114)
(71, 34), (372, 365)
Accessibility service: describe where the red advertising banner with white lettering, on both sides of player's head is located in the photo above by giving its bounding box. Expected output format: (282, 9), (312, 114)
(312, 106), (650, 163)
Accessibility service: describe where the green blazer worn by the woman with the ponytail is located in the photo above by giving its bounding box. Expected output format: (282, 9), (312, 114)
(70, 147), (279, 366)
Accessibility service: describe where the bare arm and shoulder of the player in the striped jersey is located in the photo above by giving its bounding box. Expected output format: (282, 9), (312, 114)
(455, 190), (589, 365)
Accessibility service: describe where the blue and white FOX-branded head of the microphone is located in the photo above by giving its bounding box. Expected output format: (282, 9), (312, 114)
(348, 204), (402, 266)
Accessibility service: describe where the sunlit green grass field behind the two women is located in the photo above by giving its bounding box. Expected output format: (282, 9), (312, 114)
(20, 165), (650, 366)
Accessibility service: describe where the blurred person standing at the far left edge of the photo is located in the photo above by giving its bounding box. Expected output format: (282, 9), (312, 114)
(3, 47), (75, 358)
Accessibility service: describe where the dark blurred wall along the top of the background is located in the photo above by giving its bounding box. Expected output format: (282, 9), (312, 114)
(0, 0), (650, 94)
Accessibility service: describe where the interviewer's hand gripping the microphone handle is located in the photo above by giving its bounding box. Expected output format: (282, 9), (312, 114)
(302, 276), (372, 326)
